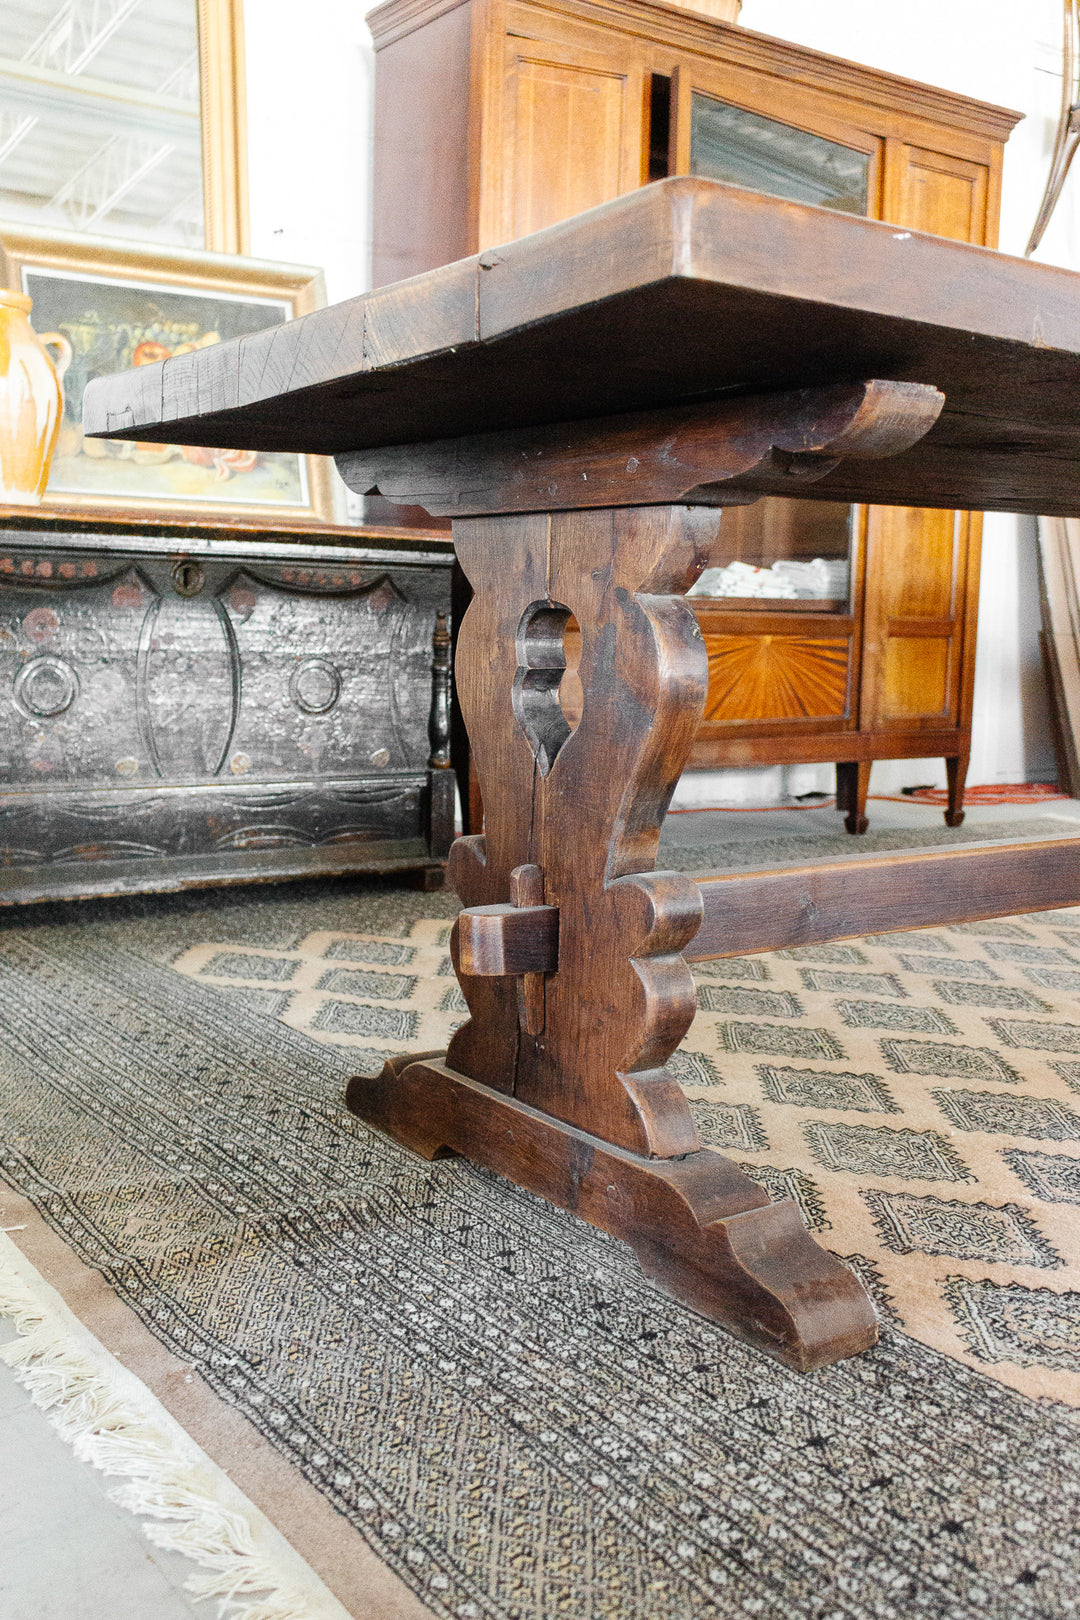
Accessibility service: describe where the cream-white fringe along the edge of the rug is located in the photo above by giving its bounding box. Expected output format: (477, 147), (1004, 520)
(0, 1239), (345, 1620)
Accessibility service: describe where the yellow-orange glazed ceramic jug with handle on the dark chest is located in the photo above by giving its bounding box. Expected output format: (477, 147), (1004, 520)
(0, 287), (71, 505)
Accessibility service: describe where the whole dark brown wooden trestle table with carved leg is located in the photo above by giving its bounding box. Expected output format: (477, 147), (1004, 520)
(84, 178), (1080, 1369)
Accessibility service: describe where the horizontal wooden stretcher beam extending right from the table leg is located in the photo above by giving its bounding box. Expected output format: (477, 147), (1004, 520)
(683, 838), (1080, 962)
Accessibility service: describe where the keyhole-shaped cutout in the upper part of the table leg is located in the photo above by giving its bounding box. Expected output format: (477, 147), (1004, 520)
(513, 601), (581, 776)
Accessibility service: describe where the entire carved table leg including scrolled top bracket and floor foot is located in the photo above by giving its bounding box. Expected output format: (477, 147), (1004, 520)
(338, 379), (942, 1367)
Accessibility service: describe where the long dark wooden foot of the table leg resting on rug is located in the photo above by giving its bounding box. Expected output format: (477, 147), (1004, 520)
(347, 1053), (878, 1372)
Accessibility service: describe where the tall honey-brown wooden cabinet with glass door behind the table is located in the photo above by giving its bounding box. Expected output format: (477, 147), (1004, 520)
(369, 0), (1018, 833)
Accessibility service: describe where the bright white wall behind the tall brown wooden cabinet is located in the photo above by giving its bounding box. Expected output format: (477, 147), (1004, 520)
(244, 0), (1080, 802)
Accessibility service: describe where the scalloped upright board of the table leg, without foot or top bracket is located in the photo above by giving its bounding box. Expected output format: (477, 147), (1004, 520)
(447, 507), (717, 1157)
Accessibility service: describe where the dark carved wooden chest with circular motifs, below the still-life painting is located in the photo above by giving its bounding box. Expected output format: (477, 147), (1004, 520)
(0, 507), (455, 904)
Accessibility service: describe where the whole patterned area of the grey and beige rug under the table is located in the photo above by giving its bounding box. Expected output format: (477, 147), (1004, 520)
(0, 823), (1080, 1620)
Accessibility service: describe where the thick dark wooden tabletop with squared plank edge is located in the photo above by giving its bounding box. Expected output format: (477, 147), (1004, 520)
(83, 178), (1080, 515)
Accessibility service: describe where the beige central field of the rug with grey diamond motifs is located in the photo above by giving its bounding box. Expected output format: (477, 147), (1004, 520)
(173, 909), (1080, 1408)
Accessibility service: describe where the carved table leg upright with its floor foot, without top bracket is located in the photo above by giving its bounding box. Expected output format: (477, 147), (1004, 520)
(348, 505), (876, 1369)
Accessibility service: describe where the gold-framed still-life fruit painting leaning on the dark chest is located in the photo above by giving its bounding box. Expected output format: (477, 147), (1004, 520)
(0, 225), (334, 522)
